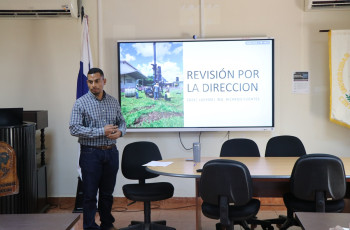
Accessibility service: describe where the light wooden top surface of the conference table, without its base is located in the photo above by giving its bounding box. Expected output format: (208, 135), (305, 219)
(147, 157), (350, 179)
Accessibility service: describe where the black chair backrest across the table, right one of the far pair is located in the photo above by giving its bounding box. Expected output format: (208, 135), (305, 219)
(265, 135), (306, 157)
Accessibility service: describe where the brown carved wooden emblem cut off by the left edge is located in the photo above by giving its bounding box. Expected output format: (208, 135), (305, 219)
(0, 141), (19, 196)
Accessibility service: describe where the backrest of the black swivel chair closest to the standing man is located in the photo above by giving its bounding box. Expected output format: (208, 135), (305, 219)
(121, 141), (162, 181)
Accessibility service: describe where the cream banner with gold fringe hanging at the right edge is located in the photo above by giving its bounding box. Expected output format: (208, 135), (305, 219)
(329, 30), (350, 128)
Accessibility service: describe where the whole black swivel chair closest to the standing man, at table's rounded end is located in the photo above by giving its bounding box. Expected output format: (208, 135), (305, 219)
(121, 141), (175, 230)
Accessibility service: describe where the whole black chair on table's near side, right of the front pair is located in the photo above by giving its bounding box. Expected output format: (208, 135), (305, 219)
(280, 154), (346, 230)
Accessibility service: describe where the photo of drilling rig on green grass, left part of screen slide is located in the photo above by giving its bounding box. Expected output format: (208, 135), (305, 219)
(119, 42), (184, 128)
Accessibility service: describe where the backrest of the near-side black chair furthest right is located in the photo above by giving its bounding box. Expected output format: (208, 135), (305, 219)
(290, 154), (346, 201)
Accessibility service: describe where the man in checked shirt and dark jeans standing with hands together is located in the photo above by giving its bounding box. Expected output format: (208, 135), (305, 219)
(69, 68), (126, 230)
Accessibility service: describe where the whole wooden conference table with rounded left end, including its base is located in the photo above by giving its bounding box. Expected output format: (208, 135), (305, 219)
(147, 157), (350, 229)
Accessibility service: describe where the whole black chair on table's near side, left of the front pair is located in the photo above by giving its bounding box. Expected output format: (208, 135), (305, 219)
(199, 159), (260, 230)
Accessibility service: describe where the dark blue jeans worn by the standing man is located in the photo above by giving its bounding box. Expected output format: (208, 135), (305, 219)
(79, 146), (119, 230)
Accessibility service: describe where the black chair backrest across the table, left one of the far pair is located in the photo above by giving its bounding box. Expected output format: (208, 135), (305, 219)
(220, 138), (260, 157)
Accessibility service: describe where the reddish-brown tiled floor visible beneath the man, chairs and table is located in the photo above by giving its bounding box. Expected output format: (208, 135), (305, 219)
(48, 199), (301, 230)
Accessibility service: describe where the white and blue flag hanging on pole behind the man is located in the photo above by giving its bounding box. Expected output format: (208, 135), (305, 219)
(77, 16), (93, 99)
